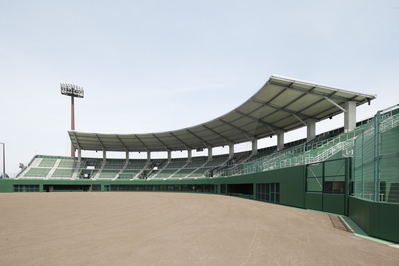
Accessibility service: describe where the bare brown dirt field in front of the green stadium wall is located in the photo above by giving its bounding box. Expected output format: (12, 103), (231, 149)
(0, 192), (399, 265)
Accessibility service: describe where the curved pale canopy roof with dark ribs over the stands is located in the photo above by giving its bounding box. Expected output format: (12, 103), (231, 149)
(68, 75), (376, 152)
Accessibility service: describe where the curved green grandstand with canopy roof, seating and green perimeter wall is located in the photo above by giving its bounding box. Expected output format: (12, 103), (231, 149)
(0, 75), (399, 242)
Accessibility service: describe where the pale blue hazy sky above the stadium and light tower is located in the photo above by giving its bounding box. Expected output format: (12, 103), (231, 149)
(0, 0), (399, 173)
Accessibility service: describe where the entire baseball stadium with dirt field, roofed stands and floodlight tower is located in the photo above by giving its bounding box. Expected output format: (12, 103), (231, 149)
(0, 75), (399, 265)
